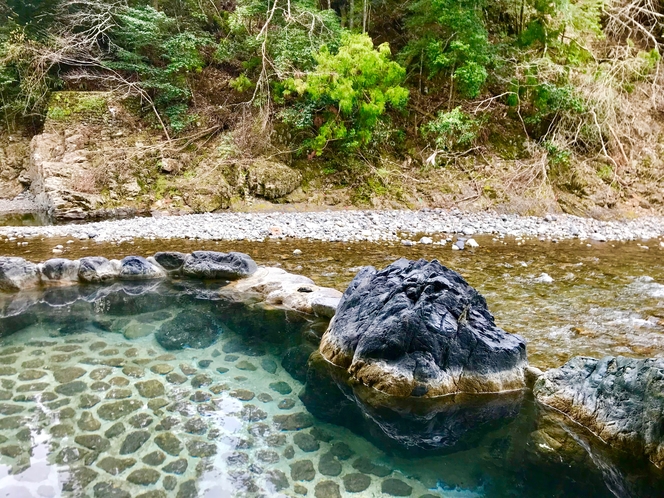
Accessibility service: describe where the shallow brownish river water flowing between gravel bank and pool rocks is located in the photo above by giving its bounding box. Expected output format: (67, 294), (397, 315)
(0, 237), (664, 368)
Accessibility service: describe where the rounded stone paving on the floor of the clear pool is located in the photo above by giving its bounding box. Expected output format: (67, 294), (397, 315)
(0, 311), (446, 498)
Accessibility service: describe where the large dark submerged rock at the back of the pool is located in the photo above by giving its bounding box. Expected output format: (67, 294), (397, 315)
(155, 309), (222, 350)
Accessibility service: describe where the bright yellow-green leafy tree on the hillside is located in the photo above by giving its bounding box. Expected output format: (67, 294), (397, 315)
(284, 33), (408, 155)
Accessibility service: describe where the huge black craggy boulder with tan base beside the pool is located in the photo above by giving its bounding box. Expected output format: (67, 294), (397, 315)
(320, 259), (527, 396)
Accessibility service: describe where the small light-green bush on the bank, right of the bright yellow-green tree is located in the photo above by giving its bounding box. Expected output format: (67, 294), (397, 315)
(422, 107), (481, 152)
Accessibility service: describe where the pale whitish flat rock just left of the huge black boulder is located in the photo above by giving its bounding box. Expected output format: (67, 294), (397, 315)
(222, 268), (342, 318)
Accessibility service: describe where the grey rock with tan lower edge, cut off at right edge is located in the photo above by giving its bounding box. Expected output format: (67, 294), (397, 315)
(533, 356), (664, 467)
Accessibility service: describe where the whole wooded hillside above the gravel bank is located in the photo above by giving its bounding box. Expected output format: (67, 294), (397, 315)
(0, 0), (664, 218)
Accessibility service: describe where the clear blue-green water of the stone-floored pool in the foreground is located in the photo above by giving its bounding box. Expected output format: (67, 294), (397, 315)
(0, 281), (664, 498)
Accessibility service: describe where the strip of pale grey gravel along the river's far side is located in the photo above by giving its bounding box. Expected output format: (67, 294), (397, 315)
(0, 209), (664, 244)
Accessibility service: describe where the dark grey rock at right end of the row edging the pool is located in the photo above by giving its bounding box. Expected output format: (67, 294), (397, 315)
(182, 251), (258, 280)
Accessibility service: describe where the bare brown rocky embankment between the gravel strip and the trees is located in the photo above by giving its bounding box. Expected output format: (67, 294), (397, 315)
(0, 92), (664, 219)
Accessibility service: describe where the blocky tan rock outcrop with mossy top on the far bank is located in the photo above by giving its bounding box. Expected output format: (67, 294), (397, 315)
(28, 92), (154, 219)
